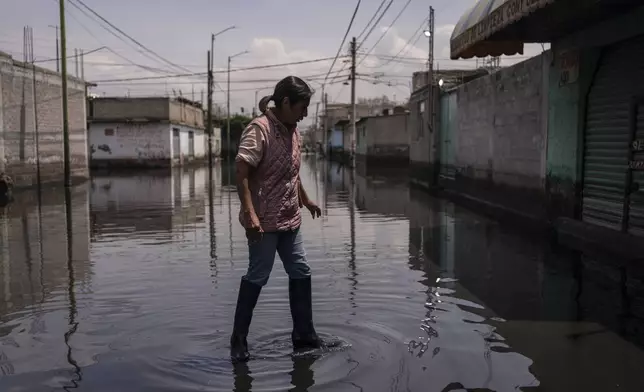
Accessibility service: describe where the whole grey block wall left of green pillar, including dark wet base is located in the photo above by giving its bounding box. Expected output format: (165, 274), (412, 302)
(440, 53), (550, 216)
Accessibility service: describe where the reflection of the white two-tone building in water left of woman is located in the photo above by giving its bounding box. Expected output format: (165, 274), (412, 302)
(90, 168), (210, 235)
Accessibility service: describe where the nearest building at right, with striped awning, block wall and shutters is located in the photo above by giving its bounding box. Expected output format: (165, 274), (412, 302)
(451, 0), (644, 254)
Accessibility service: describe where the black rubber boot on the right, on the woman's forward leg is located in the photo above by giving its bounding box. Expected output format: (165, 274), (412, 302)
(288, 277), (322, 350)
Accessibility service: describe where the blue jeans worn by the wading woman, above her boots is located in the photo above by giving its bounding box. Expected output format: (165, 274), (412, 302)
(243, 227), (311, 286)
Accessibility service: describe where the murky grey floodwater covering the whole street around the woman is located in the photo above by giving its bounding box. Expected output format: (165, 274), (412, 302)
(0, 158), (644, 392)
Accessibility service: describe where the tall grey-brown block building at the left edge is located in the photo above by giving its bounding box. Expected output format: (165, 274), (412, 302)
(0, 52), (89, 187)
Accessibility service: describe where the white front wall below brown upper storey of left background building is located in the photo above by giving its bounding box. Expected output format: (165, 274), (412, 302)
(89, 123), (172, 165)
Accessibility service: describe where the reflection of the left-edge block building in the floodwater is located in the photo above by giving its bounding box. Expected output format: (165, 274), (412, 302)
(0, 186), (92, 336)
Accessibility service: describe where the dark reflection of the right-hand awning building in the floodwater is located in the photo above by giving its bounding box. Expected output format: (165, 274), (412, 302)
(409, 192), (644, 391)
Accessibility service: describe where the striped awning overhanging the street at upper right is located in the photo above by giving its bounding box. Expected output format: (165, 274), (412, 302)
(450, 0), (554, 60)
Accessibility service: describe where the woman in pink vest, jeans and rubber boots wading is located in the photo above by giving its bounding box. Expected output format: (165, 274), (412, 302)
(230, 76), (330, 361)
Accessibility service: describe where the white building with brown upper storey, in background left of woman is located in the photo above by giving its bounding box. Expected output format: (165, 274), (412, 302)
(89, 97), (206, 168)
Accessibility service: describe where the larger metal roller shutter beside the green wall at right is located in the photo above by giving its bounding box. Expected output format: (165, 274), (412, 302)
(582, 37), (644, 230)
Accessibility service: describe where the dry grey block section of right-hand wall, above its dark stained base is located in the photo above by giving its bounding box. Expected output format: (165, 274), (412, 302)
(455, 56), (547, 189)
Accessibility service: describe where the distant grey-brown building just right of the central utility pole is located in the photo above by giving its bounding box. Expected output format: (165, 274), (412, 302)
(356, 107), (409, 166)
